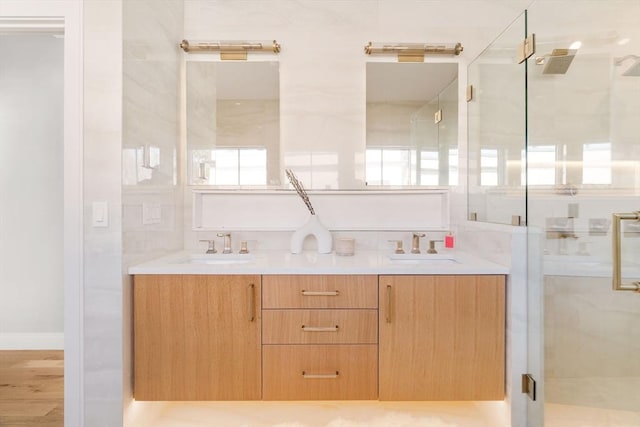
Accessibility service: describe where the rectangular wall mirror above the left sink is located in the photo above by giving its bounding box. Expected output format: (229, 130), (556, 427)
(186, 61), (281, 188)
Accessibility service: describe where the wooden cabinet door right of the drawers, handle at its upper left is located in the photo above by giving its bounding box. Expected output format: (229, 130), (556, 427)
(379, 276), (505, 400)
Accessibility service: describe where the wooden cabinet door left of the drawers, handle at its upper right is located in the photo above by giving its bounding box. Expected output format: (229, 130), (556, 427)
(134, 275), (262, 400)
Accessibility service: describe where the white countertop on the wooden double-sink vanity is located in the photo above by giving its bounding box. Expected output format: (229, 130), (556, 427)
(129, 251), (509, 275)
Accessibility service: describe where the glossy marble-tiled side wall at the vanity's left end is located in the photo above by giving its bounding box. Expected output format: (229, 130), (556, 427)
(121, 0), (184, 426)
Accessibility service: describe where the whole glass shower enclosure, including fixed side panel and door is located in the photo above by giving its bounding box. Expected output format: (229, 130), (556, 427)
(468, 0), (640, 427)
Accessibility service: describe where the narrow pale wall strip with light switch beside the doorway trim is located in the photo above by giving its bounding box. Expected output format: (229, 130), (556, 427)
(82, 0), (124, 427)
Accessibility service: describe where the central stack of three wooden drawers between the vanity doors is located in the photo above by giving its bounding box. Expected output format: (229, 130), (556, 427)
(262, 275), (378, 400)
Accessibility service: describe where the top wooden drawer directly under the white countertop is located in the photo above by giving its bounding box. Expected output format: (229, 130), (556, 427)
(262, 275), (378, 308)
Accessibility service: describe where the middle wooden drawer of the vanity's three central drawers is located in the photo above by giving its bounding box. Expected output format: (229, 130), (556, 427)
(262, 310), (378, 344)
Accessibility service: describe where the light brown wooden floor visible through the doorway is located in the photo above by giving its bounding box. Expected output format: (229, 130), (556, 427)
(0, 350), (64, 427)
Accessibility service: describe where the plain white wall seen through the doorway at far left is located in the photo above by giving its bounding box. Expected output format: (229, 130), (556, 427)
(0, 35), (64, 349)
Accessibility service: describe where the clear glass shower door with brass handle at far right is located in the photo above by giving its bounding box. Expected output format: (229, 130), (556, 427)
(527, 0), (640, 427)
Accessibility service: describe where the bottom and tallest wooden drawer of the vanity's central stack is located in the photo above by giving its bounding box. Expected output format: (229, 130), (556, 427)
(262, 344), (378, 400)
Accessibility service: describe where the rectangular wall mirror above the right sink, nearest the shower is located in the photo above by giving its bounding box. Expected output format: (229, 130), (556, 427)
(366, 62), (458, 187)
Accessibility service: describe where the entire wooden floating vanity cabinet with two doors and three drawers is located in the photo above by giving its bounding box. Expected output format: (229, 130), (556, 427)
(133, 274), (505, 401)
